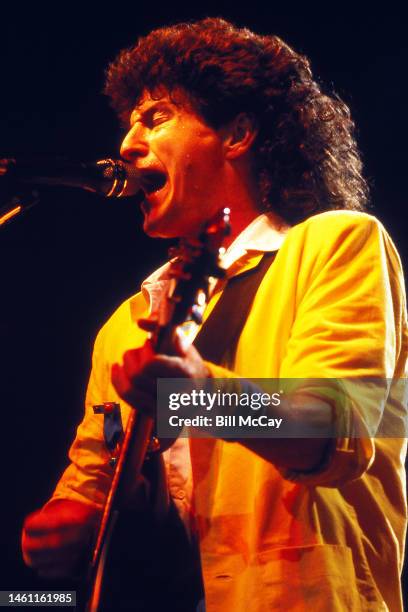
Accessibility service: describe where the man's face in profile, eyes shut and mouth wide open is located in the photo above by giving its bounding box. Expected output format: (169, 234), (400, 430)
(121, 93), (228, 238)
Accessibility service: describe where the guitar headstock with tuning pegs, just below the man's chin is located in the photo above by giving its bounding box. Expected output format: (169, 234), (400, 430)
(153, 208), (231, 352)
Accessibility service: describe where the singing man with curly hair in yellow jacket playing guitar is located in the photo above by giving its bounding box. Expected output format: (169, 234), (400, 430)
(23, 18), (408, 612)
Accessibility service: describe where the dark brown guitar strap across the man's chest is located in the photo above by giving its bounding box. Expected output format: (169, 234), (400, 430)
(194, 251), (277, 365)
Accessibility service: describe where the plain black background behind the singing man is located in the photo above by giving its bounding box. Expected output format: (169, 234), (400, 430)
(0, 2), (408, 608)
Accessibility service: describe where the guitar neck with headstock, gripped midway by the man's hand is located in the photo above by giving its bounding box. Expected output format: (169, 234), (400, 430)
(87, 209), (229, 612)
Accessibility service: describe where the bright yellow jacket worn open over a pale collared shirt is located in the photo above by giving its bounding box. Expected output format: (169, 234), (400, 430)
(54, 211), (408, 612)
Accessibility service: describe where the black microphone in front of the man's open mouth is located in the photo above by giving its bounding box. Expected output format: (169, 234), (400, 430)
(0, 158), (142, 198)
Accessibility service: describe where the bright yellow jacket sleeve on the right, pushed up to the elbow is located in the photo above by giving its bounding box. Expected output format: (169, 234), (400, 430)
(210, 213), (406, 486)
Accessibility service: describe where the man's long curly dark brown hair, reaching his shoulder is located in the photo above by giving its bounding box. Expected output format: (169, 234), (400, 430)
(105, 18), (368, 223)
